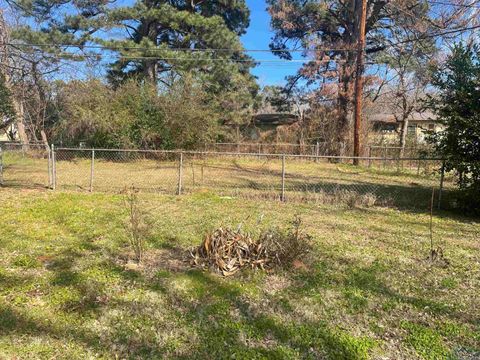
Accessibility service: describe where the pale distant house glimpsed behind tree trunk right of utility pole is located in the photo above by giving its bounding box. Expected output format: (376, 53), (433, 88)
(368, 111), (443, 142)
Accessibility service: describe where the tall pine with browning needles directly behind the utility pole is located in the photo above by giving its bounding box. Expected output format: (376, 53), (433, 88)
(267, 0), (478, 153)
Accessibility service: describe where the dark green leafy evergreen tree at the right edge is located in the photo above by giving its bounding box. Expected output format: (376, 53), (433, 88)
(427, 45), (480, 213)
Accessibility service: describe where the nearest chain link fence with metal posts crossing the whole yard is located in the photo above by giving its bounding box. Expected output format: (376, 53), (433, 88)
(1, 145), (455, 209)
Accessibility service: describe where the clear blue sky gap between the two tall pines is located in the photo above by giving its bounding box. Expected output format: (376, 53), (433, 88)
(242, 0), (301, 86)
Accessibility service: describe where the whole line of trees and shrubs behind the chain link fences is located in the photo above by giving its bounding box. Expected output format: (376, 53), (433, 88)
(2, 0), (479, 155)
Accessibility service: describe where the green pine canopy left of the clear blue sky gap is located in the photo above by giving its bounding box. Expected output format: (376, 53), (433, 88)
(11, 0), (254, 91)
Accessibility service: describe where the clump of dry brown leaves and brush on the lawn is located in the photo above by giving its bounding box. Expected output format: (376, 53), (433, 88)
(190, 217), (311, 276)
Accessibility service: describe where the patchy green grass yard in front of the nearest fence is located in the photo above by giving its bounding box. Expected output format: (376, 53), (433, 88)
(0, 188), (480, 359)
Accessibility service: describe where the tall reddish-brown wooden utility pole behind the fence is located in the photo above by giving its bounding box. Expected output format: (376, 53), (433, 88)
(353, 0), (367, 165)
